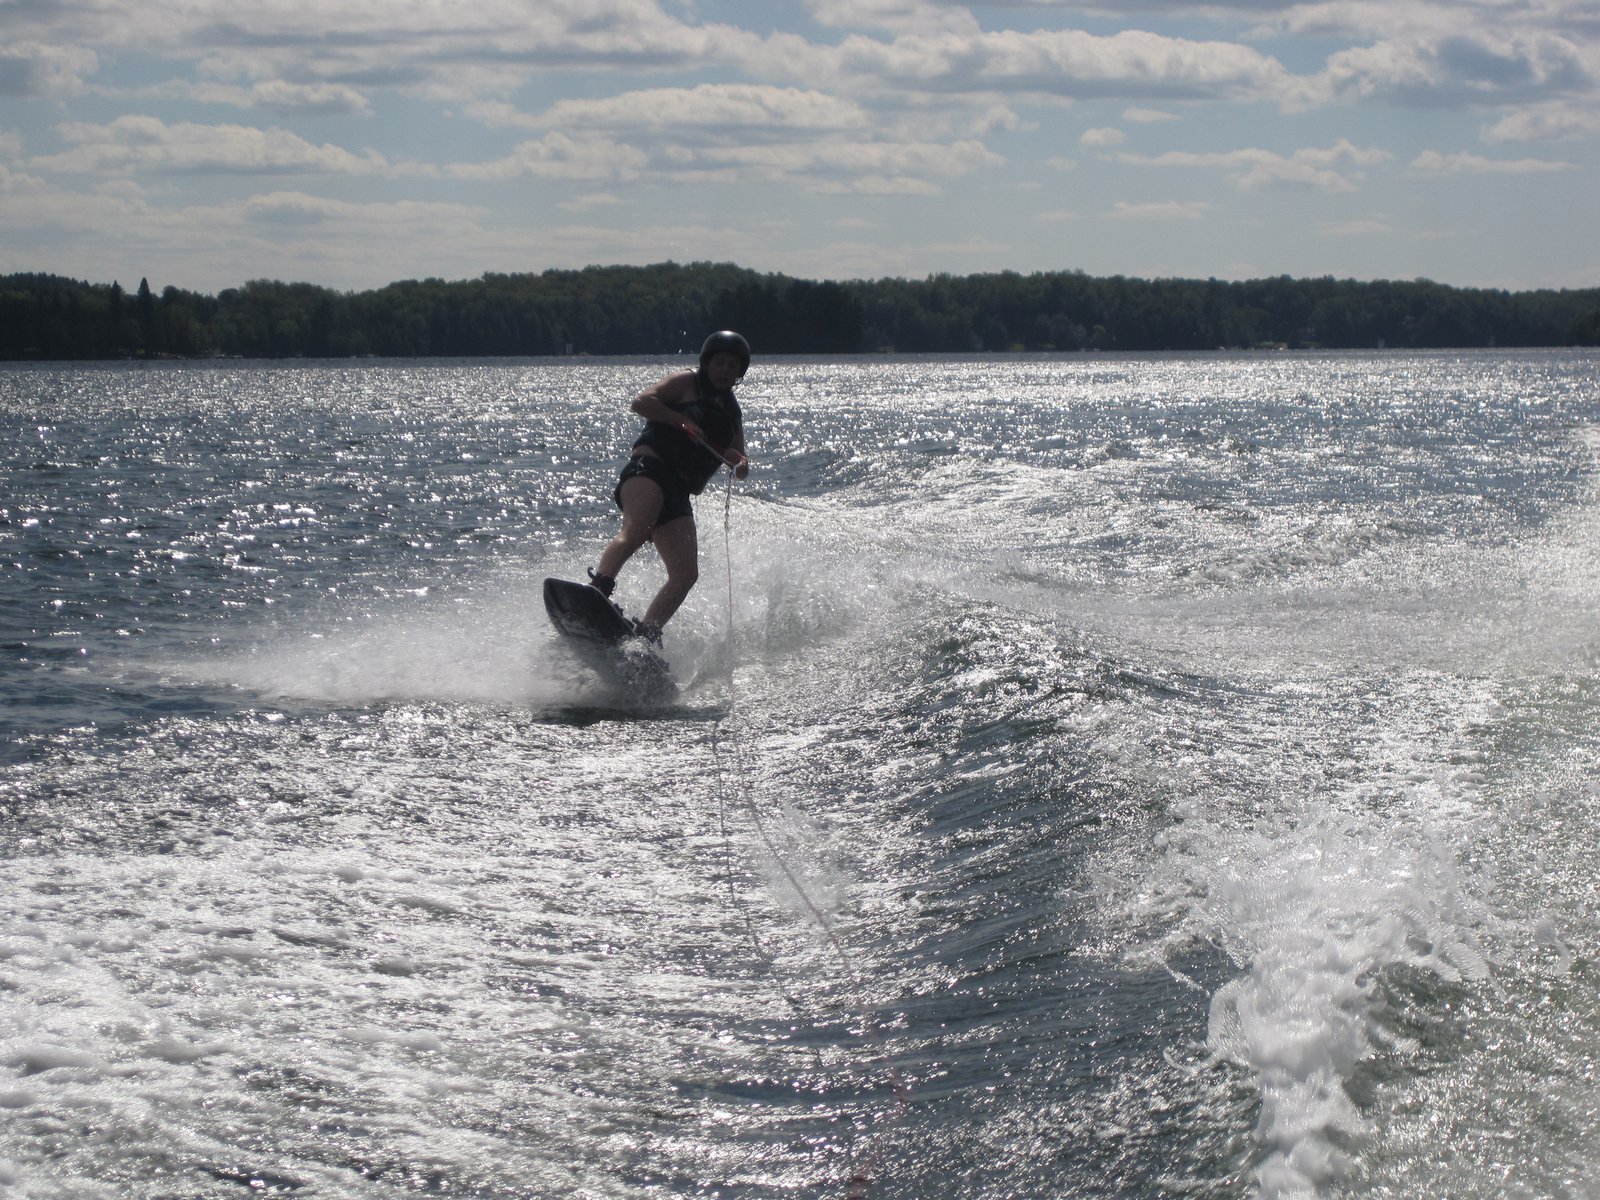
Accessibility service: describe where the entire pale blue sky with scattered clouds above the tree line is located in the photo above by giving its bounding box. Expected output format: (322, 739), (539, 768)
(0, 0), (1600, 293)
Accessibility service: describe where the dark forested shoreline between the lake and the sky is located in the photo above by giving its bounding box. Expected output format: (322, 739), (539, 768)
(0, 262), (1600, 360)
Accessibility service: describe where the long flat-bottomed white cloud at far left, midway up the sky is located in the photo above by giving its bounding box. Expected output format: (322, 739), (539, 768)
(30, 117), (387, 174)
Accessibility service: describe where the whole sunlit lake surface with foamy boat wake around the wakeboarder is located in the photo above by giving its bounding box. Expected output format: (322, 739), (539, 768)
(0, 347), (1600, 1200)
